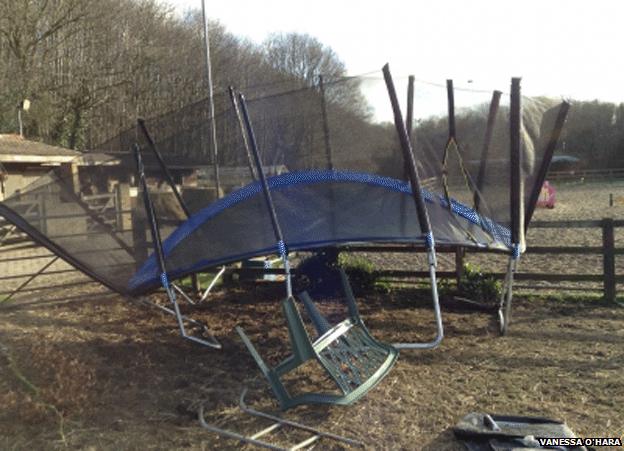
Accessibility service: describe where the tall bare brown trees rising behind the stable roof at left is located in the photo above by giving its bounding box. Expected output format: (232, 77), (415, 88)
(0, 0), (345, 150)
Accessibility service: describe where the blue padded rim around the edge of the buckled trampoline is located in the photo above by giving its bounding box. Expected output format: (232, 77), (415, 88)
(128, 169), (512, 292)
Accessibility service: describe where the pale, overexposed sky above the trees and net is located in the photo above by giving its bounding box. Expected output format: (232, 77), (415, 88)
(164, 0), (624, 102)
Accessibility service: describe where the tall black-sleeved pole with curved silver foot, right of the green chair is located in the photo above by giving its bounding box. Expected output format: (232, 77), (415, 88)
(382, 64), (444, 349)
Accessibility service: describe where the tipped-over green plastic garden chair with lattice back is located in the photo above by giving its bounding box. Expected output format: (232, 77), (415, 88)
(236, 269), (398, 410)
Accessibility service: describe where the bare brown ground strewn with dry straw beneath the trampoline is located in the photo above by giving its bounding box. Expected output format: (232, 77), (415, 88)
(0, 280), (624, 450)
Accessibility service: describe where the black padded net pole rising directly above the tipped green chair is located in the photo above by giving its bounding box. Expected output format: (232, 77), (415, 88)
(238, 94), (292, 297)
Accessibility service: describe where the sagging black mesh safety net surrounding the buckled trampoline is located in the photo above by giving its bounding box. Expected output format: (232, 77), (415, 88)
(0, 68), (567, 294)
